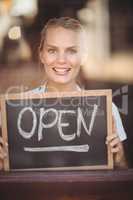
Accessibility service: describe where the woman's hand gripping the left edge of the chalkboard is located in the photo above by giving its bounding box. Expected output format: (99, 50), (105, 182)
(0, 137), (8, 170)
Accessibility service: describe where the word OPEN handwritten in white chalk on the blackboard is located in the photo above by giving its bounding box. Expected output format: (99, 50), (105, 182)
(17, 104), (98, 145)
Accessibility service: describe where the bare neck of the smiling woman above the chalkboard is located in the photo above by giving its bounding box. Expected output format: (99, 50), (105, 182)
(46, 81), (79, 92)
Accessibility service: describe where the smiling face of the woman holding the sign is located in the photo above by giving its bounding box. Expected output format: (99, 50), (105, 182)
(40, 27), (81, 88)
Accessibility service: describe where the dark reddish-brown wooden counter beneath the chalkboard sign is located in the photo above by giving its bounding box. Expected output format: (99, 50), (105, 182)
(0, 169), (133, 200)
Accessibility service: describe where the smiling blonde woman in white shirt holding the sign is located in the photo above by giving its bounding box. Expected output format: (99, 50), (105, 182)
(0, 17), (126, 167)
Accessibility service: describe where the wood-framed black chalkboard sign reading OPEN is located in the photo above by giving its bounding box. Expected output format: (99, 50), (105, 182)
(1, 90), (113, 170)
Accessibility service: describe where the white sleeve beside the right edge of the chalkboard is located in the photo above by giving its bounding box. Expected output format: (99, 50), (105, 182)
(112, 103), (127, 141)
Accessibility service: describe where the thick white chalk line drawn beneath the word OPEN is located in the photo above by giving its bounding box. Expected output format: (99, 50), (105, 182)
(24, 144), (89, 152)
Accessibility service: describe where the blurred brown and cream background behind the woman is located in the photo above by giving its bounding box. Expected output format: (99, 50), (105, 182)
(0, 0), (133, 167)
